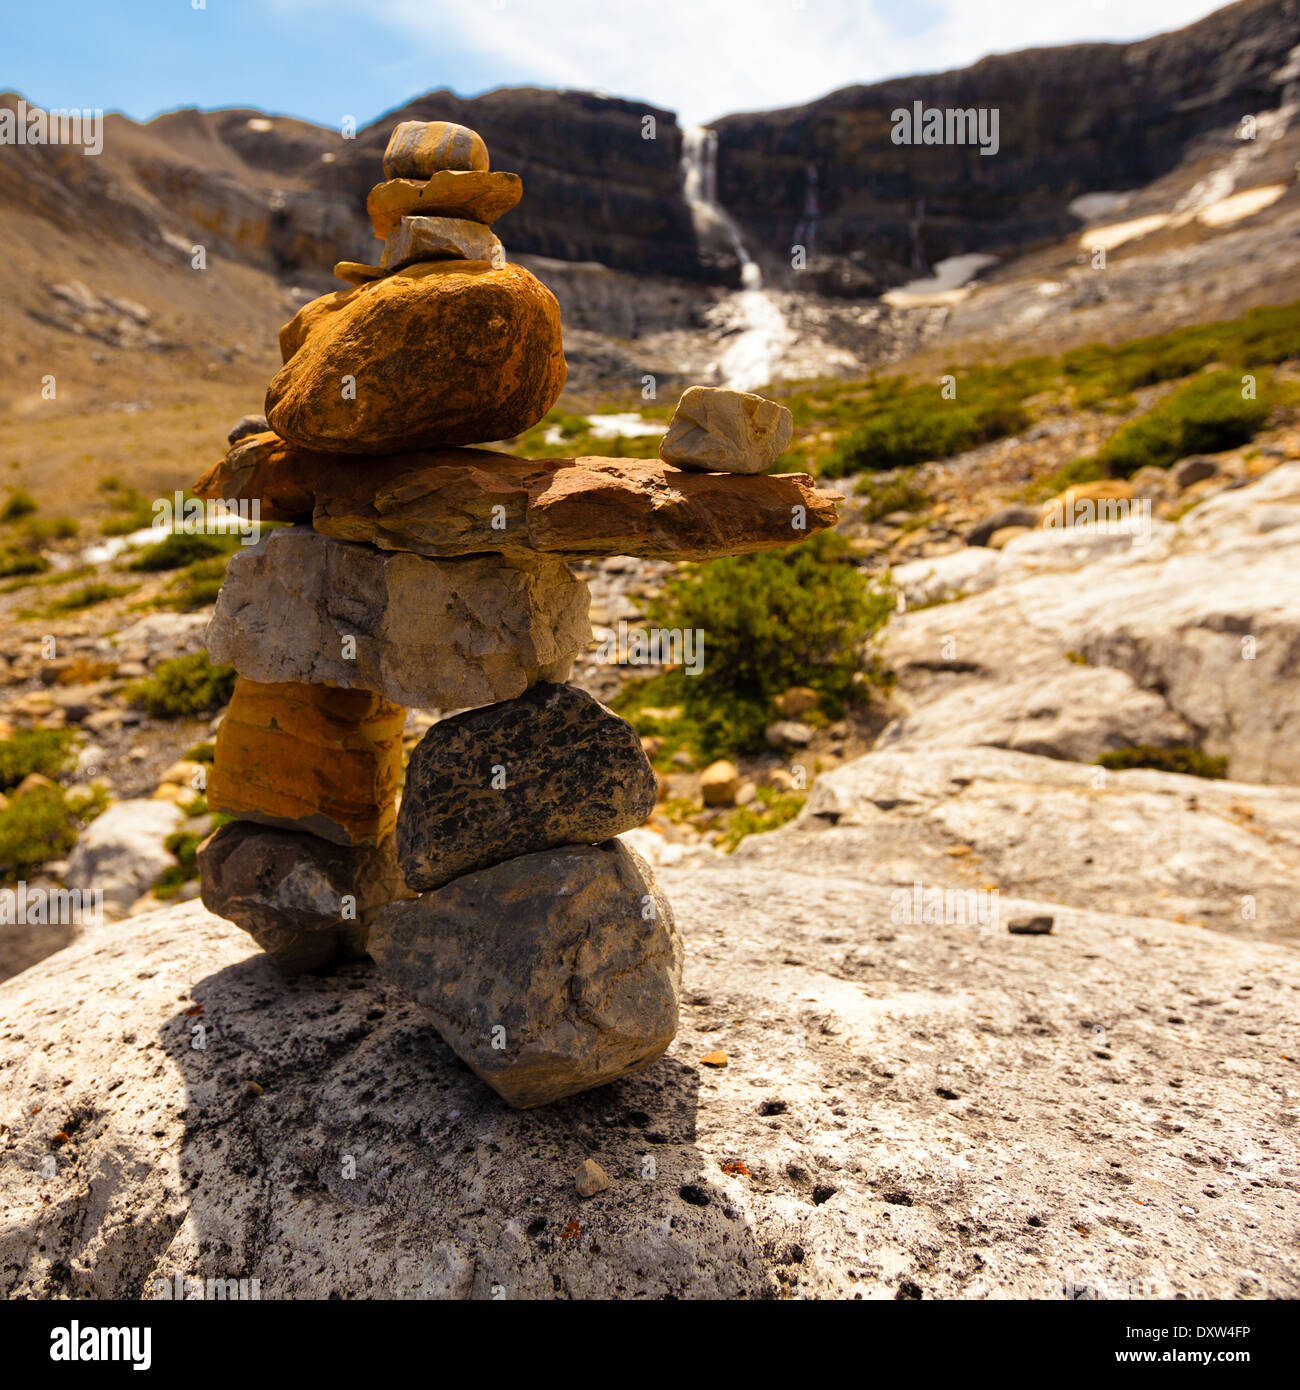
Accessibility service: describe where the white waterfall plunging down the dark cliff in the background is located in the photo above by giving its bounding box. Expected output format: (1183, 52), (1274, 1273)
(681, 125), (790, 391)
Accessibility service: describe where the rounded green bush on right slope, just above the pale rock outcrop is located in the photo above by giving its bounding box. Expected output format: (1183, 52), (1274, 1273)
(1098, 371), (1272, 478)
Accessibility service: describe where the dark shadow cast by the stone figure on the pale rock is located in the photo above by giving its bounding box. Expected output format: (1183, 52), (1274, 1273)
(157, 955), (776, 1298)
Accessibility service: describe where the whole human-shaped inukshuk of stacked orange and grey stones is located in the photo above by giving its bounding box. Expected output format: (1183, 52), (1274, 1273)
(196, 122), (837, 1106)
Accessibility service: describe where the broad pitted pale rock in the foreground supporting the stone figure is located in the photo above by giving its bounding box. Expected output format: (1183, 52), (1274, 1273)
(0, 821), (1300, 1300)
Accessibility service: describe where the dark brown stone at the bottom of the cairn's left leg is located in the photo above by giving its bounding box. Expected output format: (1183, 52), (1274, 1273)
(199, 820), (407, 974)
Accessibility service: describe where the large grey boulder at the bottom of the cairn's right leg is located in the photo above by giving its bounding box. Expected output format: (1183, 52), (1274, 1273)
(370, 840), (681, 1109)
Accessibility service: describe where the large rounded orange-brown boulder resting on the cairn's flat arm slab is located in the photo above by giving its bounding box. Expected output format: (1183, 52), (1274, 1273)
(266, 260), (567, 453)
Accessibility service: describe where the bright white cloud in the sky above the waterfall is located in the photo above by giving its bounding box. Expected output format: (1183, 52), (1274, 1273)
(337, 0), (1219, 121)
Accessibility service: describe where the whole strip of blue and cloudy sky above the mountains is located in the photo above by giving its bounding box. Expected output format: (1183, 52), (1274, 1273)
(0, 0), (1218, 125)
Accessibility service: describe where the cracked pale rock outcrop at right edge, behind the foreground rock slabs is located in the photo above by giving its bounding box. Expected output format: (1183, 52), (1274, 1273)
(881, 463), (1300, 783)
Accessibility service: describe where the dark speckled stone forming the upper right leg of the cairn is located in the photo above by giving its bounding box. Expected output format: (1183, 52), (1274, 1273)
(398, 684), (658, 892)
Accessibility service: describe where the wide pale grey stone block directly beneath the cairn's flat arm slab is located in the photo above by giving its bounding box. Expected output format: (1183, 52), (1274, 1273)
(206, 525), (591, 709)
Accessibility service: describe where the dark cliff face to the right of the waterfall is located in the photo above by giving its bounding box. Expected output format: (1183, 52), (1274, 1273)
(716, 0), (1300, 291)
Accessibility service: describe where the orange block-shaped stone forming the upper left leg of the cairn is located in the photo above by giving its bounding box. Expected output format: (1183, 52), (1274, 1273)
(207, 677), (406, 845)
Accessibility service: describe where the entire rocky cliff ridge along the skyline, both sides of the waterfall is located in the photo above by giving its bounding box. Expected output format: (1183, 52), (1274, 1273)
(0, 0), (1300, 296)
